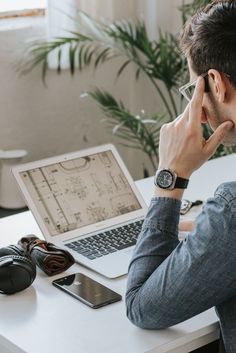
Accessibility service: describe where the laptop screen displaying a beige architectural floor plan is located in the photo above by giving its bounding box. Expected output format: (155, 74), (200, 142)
(20, 151), (141, 236)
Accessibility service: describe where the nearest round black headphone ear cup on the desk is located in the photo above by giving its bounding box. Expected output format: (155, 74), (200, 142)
(0, 255), (36, 294)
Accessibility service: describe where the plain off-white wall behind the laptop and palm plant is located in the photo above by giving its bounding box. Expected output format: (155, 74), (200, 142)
(0, 0), (183, 179)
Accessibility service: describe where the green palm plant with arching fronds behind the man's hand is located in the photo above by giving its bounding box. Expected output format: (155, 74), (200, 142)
(25, 0), (236, 176)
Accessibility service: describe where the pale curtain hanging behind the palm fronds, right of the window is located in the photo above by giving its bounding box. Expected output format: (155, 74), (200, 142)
(47, 0), (182, 68)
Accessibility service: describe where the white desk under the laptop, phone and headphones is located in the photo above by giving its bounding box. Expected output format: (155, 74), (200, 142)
(0, 155), (236, 353)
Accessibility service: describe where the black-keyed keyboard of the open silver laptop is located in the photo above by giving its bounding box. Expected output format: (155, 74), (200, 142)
(65, 220), (143, 260)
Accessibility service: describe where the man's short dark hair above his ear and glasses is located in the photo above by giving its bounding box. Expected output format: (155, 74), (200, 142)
(181, 0), (236, 88)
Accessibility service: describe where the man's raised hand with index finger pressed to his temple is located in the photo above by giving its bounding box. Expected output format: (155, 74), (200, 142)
(159, 77), (233, 179)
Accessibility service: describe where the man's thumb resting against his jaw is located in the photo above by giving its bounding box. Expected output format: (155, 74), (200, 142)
(204, 120), (234, 157)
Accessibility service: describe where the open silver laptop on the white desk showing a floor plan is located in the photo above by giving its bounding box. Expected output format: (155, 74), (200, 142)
(12, 144), (147, 278)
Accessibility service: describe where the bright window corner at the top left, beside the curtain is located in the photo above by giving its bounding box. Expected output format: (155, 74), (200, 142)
(0, 0), (46, 17)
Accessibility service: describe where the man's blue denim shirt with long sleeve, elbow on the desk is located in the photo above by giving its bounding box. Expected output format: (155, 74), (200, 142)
(126, 182), (236, 353)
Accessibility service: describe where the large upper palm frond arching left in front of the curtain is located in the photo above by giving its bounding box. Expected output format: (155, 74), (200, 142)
(22, 12), (183, 117)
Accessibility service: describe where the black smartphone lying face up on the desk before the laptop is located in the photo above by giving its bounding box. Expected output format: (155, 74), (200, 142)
(52, 273), (122, 309)
